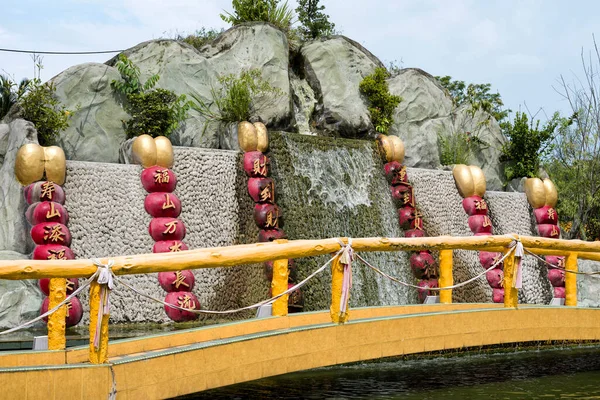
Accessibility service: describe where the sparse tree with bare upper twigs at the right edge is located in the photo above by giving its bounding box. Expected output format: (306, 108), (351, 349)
(546, 38), (600, 240)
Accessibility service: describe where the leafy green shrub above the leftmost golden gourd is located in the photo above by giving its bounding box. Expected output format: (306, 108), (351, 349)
(19, 78), (71, 146)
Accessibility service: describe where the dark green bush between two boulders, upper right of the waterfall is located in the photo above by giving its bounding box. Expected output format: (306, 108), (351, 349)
(359, 68), (402, 134)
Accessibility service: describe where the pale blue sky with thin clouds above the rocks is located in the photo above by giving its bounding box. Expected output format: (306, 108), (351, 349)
(0, 0), (600, 119)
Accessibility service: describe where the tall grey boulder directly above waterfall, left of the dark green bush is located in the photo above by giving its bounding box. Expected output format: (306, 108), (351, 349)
(300, 36), (383, 137)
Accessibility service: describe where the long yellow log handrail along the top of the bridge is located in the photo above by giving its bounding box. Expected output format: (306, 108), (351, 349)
(0, 235), (600, 280)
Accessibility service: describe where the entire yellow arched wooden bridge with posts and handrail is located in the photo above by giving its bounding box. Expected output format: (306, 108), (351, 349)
(0, 235), (600, 399)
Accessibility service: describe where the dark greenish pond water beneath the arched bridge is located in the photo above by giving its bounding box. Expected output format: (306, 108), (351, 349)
(185, 345), (600, 399)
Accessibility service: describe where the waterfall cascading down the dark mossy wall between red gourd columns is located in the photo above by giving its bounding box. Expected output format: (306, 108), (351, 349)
(270, 133), (416, 310)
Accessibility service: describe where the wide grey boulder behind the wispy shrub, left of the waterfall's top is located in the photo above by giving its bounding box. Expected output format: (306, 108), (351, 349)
(109, 23), (291, 148)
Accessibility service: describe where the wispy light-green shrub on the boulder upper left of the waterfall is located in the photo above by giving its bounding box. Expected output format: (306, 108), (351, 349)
(191, 69), (283, 126)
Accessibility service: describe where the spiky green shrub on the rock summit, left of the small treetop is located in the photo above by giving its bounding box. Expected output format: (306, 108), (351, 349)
(221, 0), (294, 32)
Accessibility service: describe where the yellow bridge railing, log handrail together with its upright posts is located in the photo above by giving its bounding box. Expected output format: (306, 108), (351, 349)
(0, 235), (600, 363)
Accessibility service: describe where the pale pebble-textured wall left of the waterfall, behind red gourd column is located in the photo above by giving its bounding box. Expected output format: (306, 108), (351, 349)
(65, 147), (267, 322)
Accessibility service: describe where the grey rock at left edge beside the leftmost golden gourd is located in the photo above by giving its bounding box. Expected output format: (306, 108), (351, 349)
(0, 119), (37, 254)
